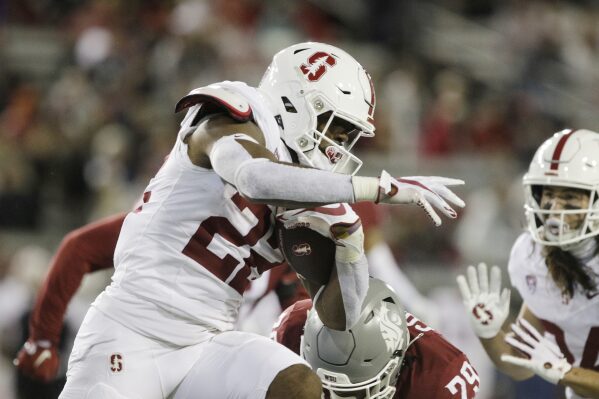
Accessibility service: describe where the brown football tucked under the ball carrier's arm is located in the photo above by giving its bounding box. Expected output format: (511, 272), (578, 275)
(275, 221), (335, 285)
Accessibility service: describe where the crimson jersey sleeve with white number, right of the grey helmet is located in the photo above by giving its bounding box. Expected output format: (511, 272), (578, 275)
(394, 313), (480, 399)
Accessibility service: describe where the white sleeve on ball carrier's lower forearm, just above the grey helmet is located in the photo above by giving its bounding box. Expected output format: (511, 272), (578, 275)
(335, 254), (368, 330)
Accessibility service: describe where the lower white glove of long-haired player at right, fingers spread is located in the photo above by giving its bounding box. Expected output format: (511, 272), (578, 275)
(501, 319), (572, 384)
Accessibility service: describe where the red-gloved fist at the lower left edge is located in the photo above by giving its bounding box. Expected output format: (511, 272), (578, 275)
(13, 339), (60, 382)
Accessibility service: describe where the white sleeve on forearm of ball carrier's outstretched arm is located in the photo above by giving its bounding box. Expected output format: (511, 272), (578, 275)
(235, 159), (353, 204)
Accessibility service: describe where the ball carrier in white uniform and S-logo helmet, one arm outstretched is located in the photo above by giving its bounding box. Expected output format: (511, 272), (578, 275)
(61, 43), (463, 399)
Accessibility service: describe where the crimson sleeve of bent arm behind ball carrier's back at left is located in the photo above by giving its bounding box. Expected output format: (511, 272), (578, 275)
(29, 214), (125, 345)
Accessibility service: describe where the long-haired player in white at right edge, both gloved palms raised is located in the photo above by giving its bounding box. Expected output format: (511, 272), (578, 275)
(458, 130), (599, 398)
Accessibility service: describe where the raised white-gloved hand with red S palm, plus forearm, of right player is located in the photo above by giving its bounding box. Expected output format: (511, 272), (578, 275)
(457, 263), (534, 380)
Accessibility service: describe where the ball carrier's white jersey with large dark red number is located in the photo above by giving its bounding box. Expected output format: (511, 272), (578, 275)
(93, 81), (291, 345)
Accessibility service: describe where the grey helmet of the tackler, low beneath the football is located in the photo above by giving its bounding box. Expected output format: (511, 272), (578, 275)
(300, 278), (410, 399)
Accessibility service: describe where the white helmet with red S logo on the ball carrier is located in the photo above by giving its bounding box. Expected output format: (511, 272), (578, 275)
(259, 42), (375, 174)
